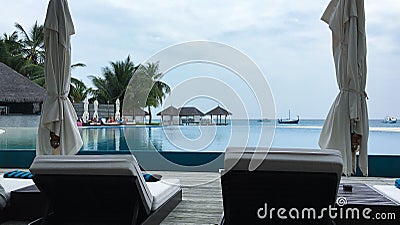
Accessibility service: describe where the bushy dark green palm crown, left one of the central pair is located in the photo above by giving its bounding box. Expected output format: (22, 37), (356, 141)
(90, 56), (137, 103)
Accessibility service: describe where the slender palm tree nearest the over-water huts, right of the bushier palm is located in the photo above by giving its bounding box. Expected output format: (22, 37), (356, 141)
(138, 63), (171, 123)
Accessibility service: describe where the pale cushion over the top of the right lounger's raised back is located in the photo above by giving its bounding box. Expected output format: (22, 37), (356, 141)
(225, 147), (342, 177)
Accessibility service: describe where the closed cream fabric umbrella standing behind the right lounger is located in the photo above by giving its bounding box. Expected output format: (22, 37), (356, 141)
(319, 0), (369, 176)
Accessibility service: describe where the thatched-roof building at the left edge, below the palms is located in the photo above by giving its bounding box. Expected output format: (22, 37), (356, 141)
(0, 62), (46, 115)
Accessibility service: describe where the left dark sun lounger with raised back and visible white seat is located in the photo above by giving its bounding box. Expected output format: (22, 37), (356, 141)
(30, 155), (182, 225)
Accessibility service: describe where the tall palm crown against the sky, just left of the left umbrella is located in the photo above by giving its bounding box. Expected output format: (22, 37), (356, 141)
(15, 21), (45, 65)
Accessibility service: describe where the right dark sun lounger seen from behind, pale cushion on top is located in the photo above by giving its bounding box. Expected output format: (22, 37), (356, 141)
(221, 148), (342, 225)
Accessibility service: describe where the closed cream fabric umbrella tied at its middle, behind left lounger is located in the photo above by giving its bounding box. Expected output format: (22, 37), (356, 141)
(37, 0), (82, 155)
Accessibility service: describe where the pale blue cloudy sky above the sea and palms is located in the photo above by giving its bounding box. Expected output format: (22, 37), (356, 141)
(0, 0), (400, 119)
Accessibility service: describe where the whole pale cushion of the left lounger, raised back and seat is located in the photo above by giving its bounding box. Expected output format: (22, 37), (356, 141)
(30, 155), (180, 213)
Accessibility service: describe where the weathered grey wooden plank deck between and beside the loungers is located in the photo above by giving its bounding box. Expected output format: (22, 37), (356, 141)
(0, 169), (395, 225)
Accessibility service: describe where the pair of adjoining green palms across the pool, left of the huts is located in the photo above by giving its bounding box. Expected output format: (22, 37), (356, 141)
(90, 56), (171, 123)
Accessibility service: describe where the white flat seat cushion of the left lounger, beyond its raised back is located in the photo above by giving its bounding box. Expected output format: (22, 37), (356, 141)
(146, 179), (181, 211)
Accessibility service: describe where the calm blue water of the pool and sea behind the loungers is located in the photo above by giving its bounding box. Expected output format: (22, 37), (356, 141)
(0, 120), (400, 155)
